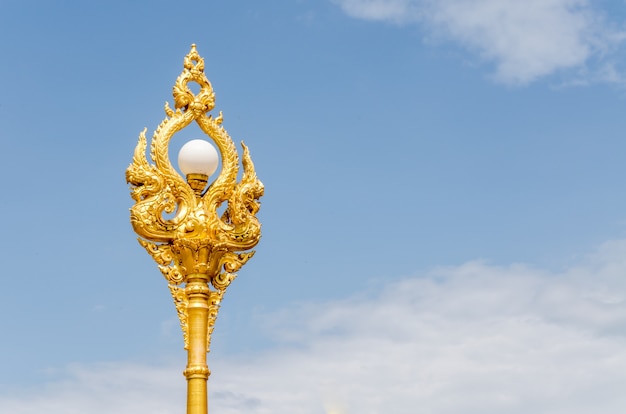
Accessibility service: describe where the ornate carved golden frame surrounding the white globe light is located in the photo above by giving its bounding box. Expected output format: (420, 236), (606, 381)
(126, 45), (263, 258)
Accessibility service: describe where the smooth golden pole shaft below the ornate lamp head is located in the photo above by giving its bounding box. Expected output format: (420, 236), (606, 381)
(184, 274), (210, 414)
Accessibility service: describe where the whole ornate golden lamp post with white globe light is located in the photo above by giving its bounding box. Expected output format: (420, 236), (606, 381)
(126, 45), (263, 414)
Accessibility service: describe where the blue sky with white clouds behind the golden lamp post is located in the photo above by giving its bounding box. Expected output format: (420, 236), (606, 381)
(0, 0), (626, 414)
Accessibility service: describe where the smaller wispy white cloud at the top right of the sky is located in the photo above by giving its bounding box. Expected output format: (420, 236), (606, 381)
(334, 0), (625, 84)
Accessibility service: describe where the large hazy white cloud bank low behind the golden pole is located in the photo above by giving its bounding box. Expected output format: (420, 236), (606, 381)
(0, 241), (626, 414)
